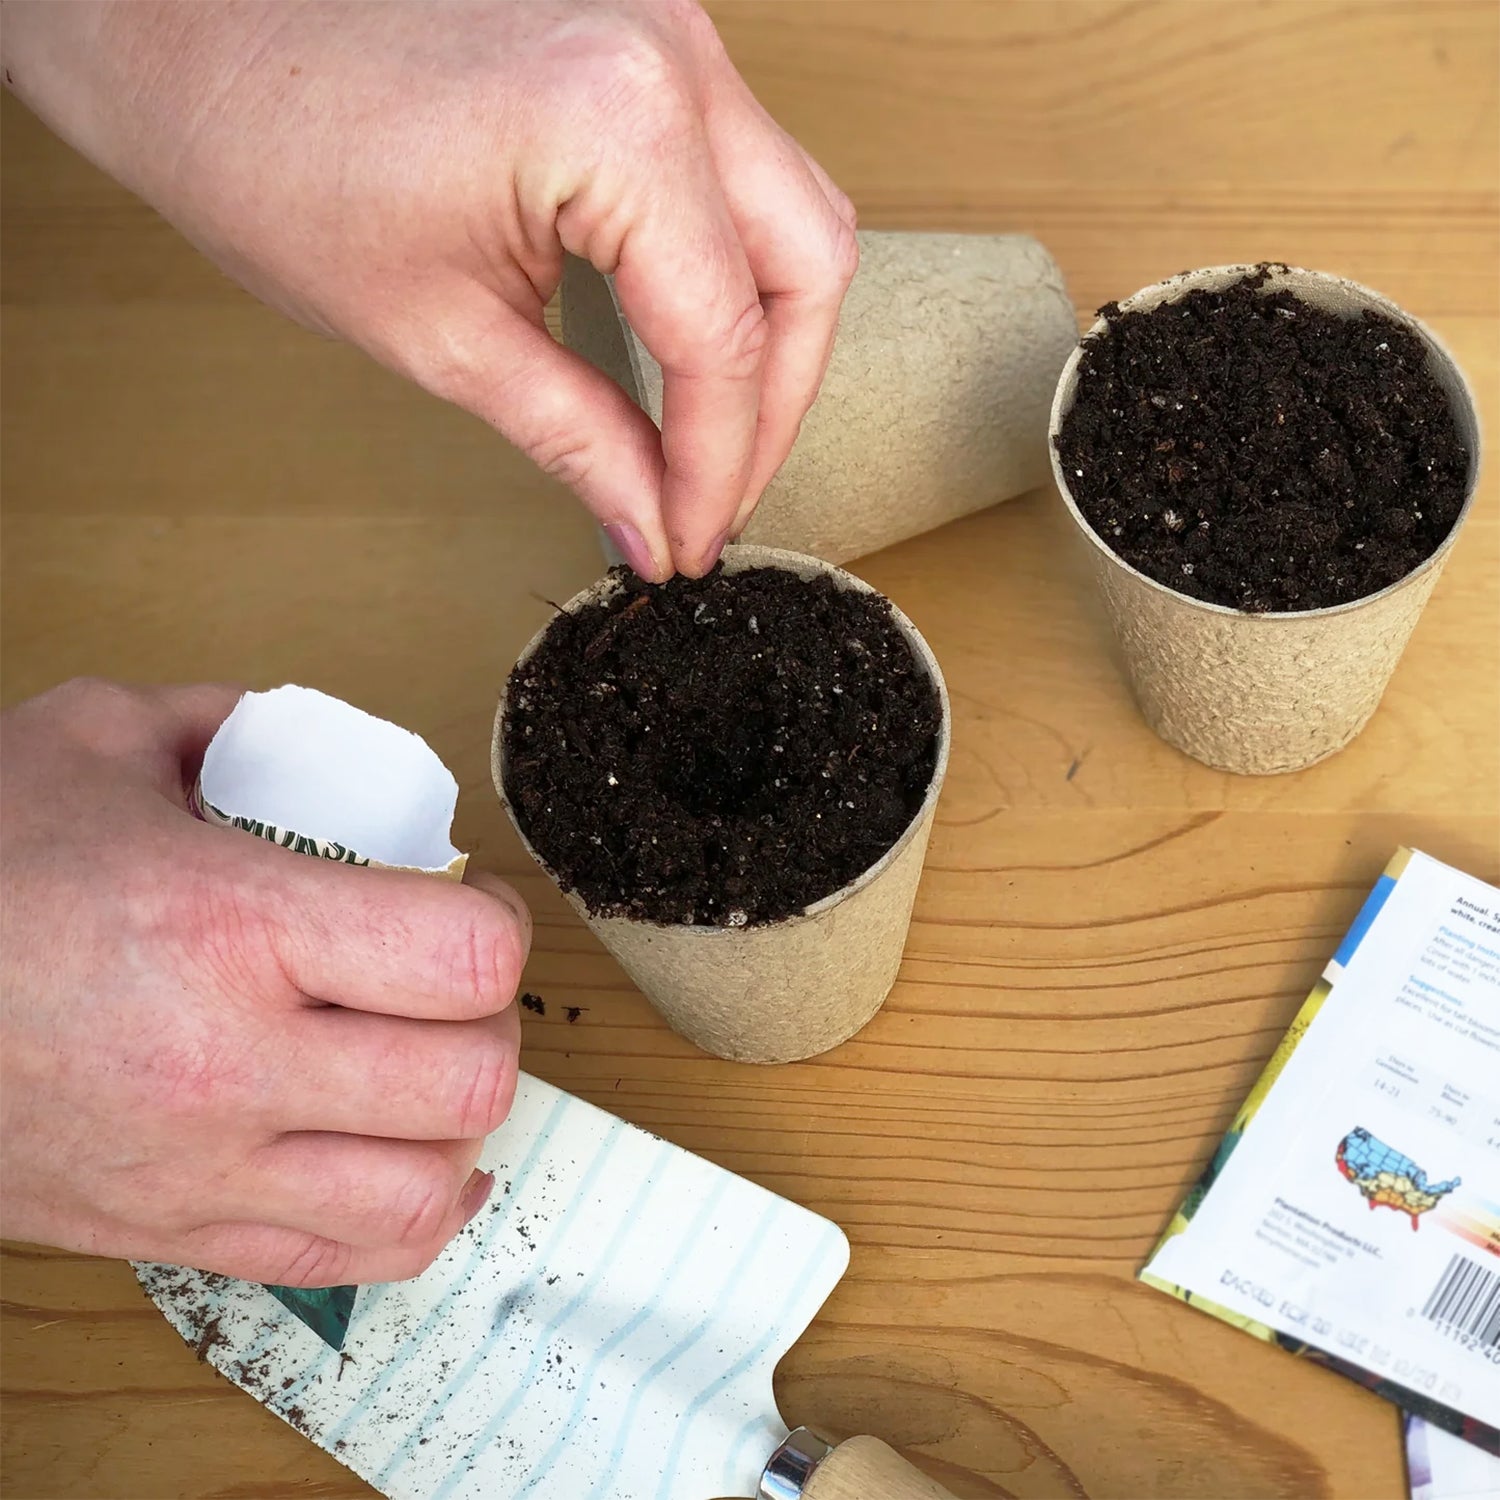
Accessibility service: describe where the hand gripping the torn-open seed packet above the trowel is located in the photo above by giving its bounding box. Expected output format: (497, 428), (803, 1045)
(0, 681), (531, 1287)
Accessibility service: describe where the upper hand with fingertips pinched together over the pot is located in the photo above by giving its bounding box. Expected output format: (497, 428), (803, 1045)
(6, 0), (858, 581)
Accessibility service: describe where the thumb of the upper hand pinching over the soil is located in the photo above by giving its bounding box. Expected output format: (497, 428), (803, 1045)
(416, 290), (672, 584)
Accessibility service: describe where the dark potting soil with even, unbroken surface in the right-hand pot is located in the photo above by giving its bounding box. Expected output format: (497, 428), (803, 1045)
(1058, 267), (1469, 612)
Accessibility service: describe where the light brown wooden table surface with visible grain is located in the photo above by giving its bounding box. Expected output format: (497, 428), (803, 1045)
(3, 0), (1500, 1500)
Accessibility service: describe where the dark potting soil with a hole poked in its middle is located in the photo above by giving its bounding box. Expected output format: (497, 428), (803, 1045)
(504, 569), (941, 927)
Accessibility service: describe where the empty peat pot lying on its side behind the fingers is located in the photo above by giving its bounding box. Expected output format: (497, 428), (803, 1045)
(563, 230), (1079, 563)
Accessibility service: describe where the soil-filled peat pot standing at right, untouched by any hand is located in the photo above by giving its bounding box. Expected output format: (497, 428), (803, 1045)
(1052, 266), (1479, 774)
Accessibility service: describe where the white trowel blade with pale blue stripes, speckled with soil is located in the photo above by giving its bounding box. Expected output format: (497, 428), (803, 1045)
(137, 1076), (849, 1500)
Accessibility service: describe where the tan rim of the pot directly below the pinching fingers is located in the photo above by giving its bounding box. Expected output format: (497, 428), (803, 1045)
(491, 543), (953, 941)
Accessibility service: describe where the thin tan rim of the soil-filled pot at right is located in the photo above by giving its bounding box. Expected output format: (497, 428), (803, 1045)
(1047, 261), (1482, 624)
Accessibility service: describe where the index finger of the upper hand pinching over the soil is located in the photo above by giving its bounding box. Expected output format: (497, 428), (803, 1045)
(615, 152), (768, 578)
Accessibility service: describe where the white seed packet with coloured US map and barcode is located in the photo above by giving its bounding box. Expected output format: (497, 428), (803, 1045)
(1140, 849), (1500, 1454)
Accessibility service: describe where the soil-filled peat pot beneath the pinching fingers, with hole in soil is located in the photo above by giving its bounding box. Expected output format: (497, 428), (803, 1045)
(491, 546), (950, 1062)
